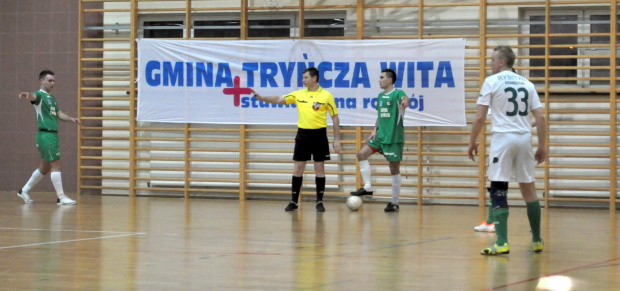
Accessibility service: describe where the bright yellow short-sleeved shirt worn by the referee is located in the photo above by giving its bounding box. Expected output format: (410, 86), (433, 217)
(284, 86), (338, 129)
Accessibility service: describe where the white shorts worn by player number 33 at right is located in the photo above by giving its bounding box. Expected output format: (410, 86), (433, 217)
(487, 133), (536, 183)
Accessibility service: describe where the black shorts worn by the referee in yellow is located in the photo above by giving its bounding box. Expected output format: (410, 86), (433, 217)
(293, 128), (330, 162)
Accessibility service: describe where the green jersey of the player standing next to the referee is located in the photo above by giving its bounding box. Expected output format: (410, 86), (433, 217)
(376, 89), (406, 144)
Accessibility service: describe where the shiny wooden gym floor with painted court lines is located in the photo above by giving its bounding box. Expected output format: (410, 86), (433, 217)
(0, 192), (620, 290)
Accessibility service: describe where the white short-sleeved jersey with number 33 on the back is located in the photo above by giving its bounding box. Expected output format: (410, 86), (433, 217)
(477, 71), (542, 133)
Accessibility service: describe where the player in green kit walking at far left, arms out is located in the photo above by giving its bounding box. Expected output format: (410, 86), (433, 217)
(17, 70), (80, 205)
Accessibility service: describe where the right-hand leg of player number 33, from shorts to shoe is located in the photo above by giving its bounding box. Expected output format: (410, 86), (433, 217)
(515, 134), (544, 252)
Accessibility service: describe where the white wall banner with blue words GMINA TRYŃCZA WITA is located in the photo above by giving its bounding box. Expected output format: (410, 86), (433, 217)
(138, 39), (466, 126)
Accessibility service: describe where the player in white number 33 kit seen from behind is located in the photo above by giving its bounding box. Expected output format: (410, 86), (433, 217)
(468, 46), (547, 255)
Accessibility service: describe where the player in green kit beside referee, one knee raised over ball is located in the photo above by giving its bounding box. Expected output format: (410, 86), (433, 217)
(351, 69), (409, 212)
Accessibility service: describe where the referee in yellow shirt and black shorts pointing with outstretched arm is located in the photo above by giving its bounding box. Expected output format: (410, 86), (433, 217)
(252, 67), (340, 212)
